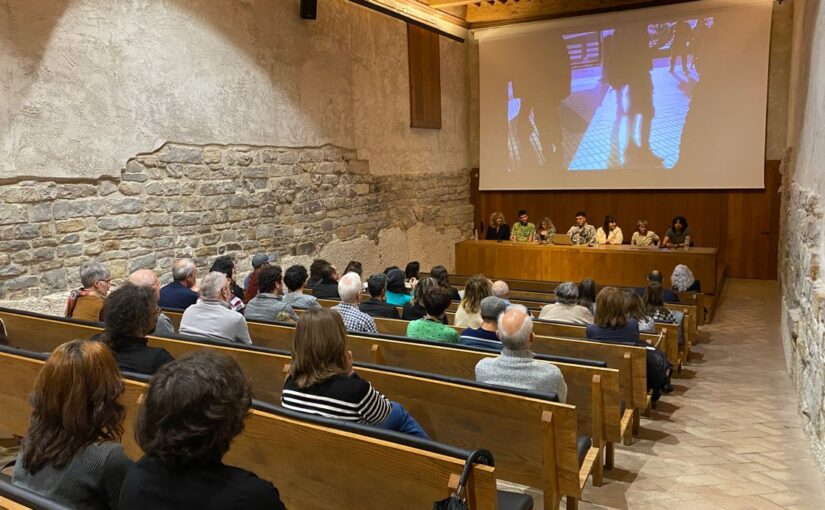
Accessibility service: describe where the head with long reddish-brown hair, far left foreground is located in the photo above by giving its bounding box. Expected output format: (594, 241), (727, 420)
(20, 340), (126, 474)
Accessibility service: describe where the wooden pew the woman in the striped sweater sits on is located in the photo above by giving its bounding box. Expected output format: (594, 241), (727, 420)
(0, 347), (497, 510)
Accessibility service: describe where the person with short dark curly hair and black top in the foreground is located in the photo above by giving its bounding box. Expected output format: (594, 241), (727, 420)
(118, 351), (285, 510)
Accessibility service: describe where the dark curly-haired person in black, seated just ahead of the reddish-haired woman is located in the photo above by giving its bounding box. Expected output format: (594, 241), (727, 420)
(100, 283), (174, 374)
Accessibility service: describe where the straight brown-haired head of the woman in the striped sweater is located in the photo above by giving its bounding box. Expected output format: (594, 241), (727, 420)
(289, 308), (350, 388)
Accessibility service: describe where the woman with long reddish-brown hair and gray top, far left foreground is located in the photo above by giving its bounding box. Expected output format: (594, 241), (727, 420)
(12, 340), (132, 510)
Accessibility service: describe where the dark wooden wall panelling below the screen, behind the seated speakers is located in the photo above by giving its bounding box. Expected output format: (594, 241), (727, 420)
(471, 161), (781, 280)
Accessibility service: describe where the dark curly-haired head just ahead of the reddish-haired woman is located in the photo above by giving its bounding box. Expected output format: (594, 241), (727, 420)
(103, 277), (158, 344)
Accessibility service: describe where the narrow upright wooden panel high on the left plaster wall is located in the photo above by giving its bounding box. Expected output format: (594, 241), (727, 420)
(407, 23), (441, 129)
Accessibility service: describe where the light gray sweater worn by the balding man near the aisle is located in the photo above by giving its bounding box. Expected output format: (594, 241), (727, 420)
(476, 347), (567, 402)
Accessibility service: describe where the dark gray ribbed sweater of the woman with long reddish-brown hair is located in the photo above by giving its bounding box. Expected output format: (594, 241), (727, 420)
(12, 442), (132, 510)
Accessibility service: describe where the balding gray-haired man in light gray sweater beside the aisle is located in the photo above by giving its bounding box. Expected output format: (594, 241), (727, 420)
(476, 305), (567, 402)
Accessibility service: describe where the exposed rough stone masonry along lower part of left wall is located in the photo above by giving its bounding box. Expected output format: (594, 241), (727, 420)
(0, 144), (472, 299)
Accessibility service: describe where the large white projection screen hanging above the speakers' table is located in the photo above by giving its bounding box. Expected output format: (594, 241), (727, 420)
(475, 0), (772, 190)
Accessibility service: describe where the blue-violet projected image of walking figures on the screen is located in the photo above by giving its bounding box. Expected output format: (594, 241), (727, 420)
(507, 17), (714, 171)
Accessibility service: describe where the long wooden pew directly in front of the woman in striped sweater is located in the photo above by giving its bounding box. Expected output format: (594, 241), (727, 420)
(0, 309), (604, 509)
